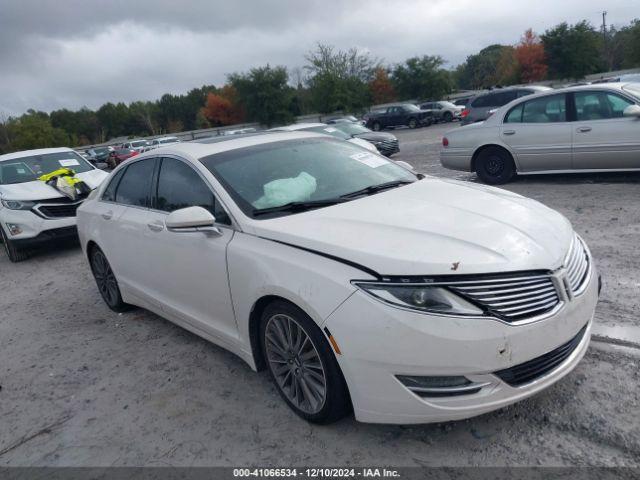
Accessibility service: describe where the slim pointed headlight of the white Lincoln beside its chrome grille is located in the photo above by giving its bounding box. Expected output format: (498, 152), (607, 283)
(354, 282), (483, 316)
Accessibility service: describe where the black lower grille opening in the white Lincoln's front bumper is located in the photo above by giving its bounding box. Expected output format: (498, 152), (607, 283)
(494, 325), (587, 387)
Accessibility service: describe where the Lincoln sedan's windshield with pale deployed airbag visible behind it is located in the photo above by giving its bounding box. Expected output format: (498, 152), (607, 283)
(201, 138), (416, 219)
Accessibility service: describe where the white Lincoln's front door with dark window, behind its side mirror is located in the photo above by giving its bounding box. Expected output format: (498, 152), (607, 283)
(141, 157), (238, 342)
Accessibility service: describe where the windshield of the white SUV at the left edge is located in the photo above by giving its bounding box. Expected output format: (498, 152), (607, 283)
(0, 152), (93, 185)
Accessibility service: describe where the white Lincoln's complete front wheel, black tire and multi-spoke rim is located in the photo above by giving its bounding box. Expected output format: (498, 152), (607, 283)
(260, 300), (351, 424)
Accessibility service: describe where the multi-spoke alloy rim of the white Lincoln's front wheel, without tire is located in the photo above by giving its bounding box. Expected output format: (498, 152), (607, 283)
(265, 314), (327, 415)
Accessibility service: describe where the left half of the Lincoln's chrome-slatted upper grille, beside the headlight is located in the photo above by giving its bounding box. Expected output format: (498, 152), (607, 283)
(449, 275), (560, 322)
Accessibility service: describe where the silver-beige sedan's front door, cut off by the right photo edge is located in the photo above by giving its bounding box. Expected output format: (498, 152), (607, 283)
(572, 90), (640, 169)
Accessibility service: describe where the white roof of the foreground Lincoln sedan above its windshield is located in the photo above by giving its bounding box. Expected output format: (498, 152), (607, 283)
(136, 131), (330, 159)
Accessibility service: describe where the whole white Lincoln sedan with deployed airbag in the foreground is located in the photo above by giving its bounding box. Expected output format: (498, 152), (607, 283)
(78, 132), (599, 423)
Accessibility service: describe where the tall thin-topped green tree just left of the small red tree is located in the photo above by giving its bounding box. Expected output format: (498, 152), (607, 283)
(304, 44), (380, 113)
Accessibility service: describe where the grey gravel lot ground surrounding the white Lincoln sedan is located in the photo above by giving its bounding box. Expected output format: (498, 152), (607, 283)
(0, 125), (640, 466)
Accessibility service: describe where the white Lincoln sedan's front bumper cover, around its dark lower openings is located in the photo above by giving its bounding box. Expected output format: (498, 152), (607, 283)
(326, 267), (598, 424)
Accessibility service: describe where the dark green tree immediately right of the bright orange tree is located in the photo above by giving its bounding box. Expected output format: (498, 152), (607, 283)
(540, 20), (604, 80)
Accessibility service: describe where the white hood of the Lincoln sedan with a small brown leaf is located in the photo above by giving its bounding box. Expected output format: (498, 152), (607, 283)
(252, 177), (573, 276)
